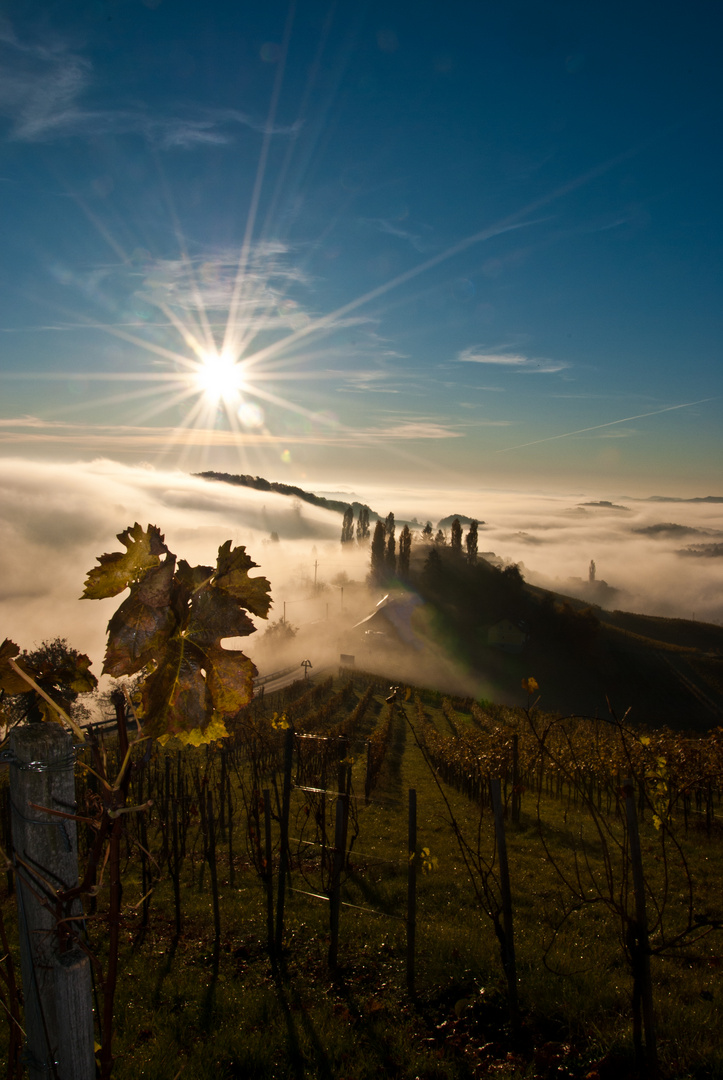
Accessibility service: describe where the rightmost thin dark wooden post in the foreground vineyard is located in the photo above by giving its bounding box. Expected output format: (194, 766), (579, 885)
(622, 779), (658, 1080)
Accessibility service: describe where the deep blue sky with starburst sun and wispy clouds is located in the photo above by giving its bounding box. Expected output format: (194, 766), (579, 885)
(0, 0), (723, 495)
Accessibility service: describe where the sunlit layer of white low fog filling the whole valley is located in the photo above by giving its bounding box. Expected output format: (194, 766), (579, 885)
(0, 458), (723, 691)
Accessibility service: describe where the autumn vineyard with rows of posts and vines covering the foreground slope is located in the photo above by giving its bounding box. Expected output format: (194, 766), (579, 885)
(0, 670), (723, 1080)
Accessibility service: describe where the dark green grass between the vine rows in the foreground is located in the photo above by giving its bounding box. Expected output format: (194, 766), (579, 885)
(1, 683), (723, 1080)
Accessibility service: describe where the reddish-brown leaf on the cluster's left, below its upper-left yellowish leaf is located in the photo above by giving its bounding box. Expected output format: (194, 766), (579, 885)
(103, 554), (177, 678)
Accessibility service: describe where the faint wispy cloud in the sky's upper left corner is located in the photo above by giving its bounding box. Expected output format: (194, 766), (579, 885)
(0, 23), (299, 149)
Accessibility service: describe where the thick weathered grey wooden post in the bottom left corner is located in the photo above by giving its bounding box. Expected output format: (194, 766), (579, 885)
(10, 723), (95, 1080)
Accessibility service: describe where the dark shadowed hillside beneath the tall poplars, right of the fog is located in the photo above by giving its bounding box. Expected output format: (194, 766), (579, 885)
(379, 545), (723, 731)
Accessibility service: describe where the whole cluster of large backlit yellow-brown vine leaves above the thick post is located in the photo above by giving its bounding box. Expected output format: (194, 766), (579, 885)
(84, 525), (271, 745)
